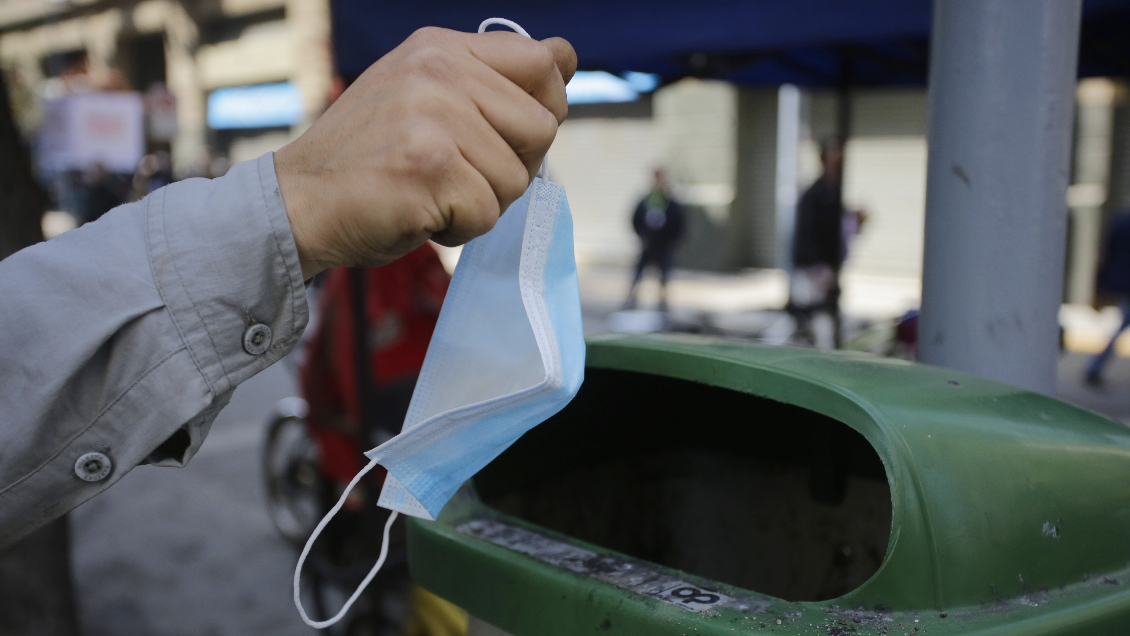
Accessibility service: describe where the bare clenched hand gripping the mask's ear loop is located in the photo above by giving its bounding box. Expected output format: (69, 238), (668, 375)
(275, 27), (576, 280)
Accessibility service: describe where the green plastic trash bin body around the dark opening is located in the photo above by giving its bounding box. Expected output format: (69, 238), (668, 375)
(409, 336), (1130, 636)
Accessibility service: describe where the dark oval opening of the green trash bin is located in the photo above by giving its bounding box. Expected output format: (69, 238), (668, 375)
(475, 369), (892, 601)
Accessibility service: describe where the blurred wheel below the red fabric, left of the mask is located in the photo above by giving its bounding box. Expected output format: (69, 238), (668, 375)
(263, 398), (324, 546)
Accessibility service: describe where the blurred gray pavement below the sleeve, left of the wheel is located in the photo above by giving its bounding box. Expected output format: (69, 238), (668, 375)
(71, 364), (316, 636)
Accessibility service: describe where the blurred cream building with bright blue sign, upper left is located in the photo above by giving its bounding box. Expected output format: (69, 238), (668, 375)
(0, 0), (333, 175)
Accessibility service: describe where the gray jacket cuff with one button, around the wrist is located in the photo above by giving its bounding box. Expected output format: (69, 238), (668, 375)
(146, 153), (308, 397)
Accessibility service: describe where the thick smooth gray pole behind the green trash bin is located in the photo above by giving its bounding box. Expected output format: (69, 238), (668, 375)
(919, 0), (1081, 393)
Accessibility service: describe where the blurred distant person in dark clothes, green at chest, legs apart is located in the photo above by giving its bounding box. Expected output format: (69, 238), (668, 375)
(624, 168), (686, 312)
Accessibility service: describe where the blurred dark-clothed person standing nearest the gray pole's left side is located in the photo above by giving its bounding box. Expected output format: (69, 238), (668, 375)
(786, 138), (867, 348)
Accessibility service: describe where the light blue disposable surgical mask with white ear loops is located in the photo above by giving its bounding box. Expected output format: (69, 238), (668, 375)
(294, 20), (584, 628)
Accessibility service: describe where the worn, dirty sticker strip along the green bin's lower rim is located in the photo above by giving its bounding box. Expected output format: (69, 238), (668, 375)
(455, 519), (732, 612)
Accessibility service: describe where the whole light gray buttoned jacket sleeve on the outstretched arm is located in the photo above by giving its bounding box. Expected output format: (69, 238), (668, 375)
(0, 154), (307, 547)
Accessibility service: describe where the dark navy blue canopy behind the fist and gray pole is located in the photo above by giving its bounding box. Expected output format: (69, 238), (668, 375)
(332, 0), (1130, 88)
